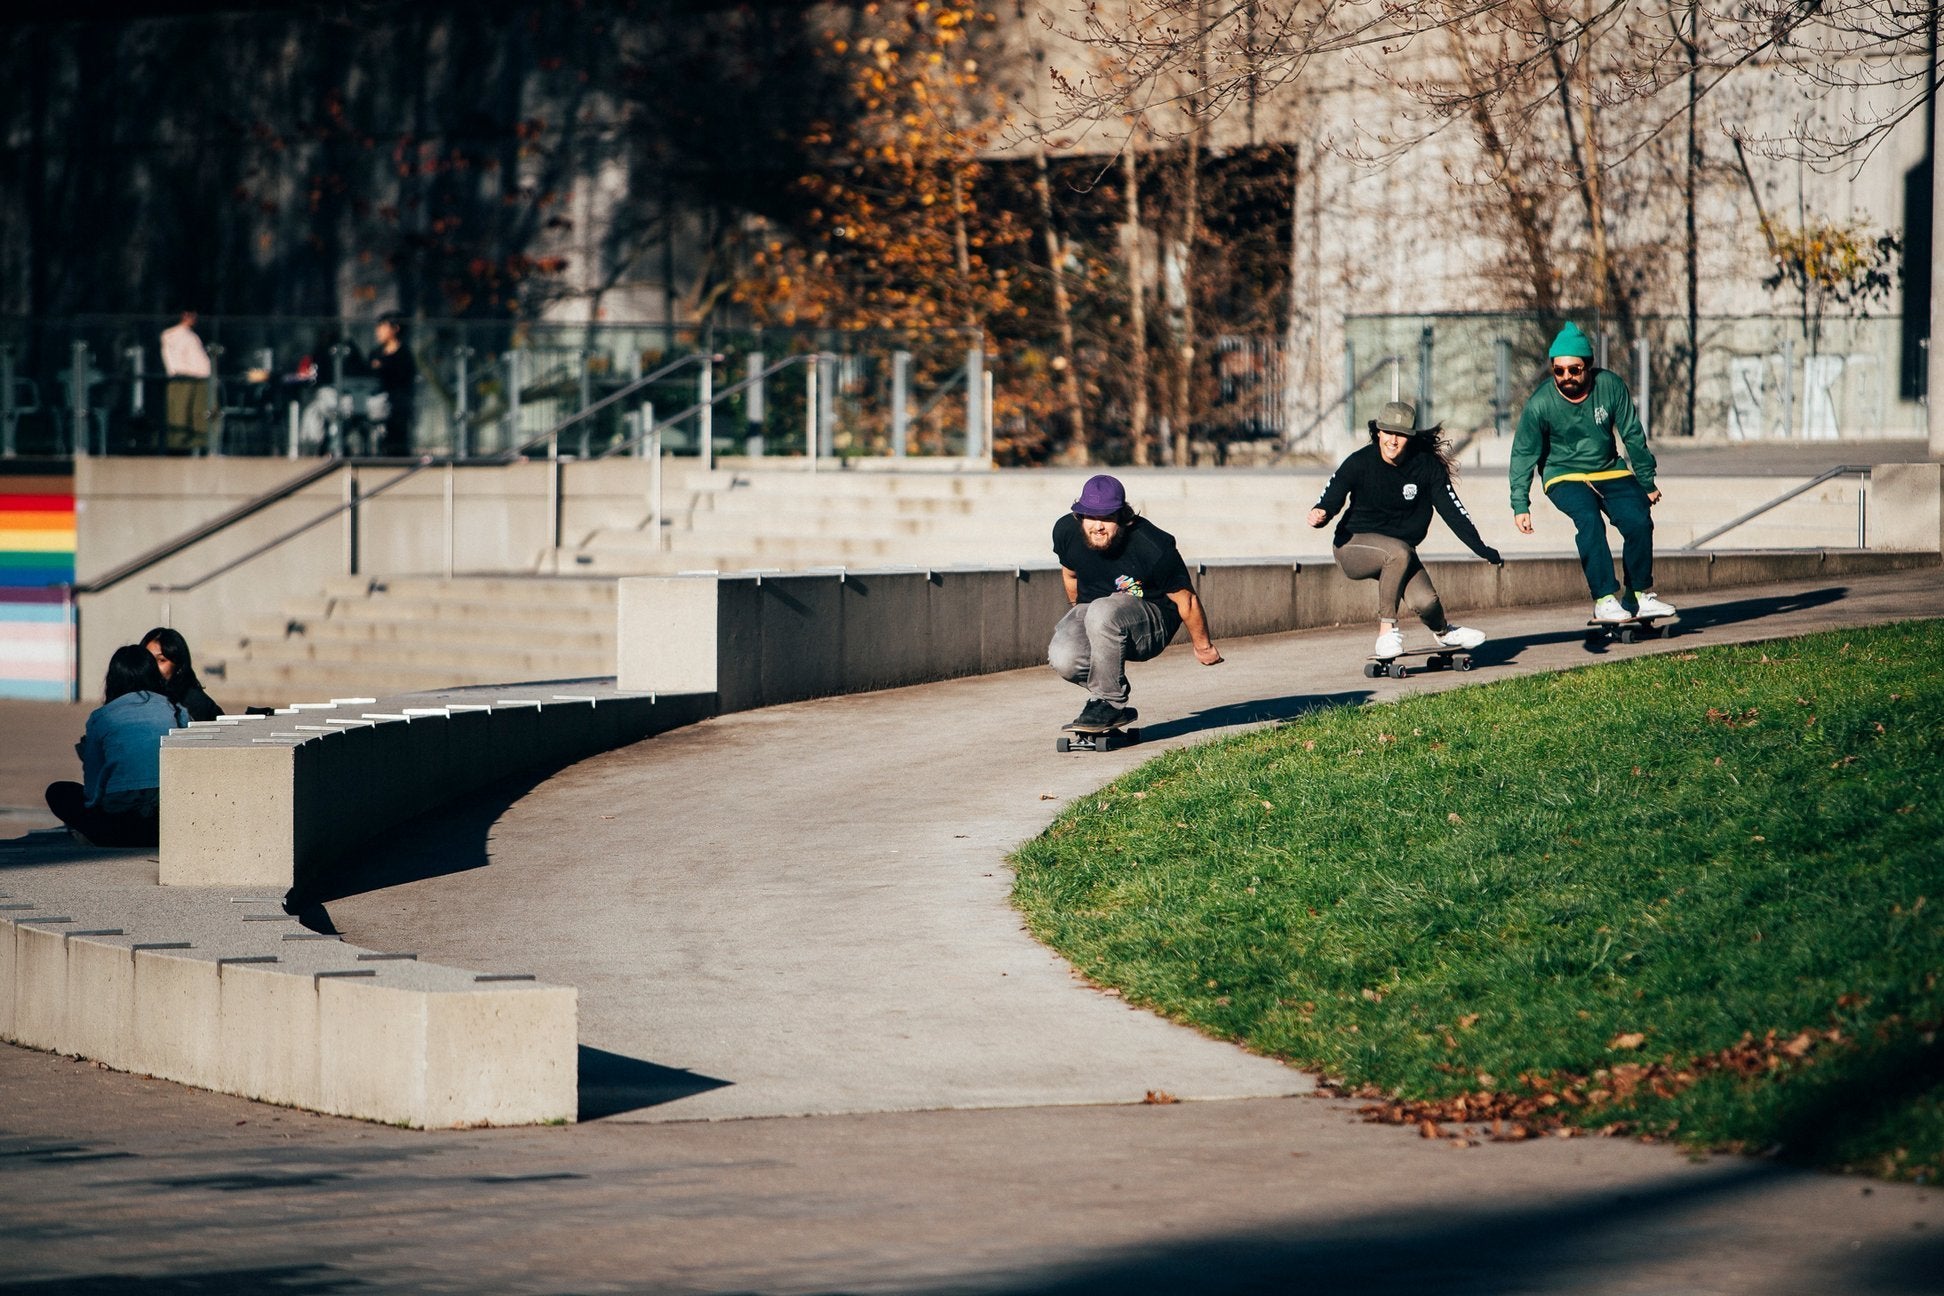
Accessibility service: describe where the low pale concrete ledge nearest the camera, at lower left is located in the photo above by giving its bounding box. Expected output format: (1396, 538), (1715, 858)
(0, 888), (579, 1127)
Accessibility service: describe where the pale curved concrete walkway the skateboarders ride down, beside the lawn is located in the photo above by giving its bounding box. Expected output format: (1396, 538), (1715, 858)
(329, 569), (1944, 1119)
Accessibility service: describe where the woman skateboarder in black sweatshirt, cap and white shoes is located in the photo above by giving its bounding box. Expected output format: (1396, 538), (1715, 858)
(1310, 400), (1505, 661)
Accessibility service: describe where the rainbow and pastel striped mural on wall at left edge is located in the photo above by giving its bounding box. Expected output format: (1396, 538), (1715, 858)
(0, 464), (74, 701)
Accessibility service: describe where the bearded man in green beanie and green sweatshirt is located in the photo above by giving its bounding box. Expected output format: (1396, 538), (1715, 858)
(1510, 324), (1674, 622)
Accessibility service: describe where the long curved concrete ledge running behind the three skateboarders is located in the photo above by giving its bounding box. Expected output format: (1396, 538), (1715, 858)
(618, 548), (1940, 711)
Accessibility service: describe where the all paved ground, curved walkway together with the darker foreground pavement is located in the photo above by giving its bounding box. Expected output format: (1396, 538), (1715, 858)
(0, 569), (1944, 1294)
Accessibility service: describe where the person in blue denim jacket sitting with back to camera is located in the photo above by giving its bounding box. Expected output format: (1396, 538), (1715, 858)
(47, 643), (189, 845)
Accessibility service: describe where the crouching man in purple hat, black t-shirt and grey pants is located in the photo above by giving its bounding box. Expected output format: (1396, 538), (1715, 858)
(1046, 474), (1221, 729)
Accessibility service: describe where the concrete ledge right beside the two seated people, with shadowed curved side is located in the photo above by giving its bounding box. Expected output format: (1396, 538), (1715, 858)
(161, 680), (713, 890)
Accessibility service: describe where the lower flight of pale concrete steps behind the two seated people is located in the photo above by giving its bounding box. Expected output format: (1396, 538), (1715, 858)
(210, 575), (614, 709)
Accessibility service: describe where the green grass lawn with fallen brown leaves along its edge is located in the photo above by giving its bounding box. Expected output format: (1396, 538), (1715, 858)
(1015, 622), (1944, 1181)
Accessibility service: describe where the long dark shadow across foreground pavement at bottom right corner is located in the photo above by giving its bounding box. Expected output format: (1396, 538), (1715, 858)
(909, 1162), (1944, 1296)
